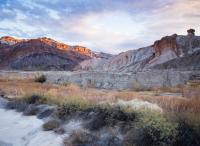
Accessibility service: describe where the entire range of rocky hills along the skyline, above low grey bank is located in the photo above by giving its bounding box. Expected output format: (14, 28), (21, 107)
(0, 29), (200, 73)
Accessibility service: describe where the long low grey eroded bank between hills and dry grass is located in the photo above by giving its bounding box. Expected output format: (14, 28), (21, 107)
(0, 70), (200, 90)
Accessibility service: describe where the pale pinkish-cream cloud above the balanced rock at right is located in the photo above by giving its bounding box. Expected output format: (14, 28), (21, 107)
(143, 0), (200, 35)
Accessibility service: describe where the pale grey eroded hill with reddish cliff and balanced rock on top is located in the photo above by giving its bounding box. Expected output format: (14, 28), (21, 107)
(99, 29), (200, 73)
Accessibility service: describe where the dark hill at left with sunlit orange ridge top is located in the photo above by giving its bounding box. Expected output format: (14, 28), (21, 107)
(0, 36), (101, 70)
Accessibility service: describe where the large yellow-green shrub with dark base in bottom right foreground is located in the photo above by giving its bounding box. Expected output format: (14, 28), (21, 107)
(137, 112), (178, 146)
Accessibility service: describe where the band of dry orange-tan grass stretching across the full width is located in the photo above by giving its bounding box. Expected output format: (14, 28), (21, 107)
(0, 79), (200, 113)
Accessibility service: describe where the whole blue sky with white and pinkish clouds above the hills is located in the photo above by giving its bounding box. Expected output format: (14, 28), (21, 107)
(0, 0), (200, 54)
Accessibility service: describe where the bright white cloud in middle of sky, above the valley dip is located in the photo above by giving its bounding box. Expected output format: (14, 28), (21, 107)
(59, 11), (145, 53)
